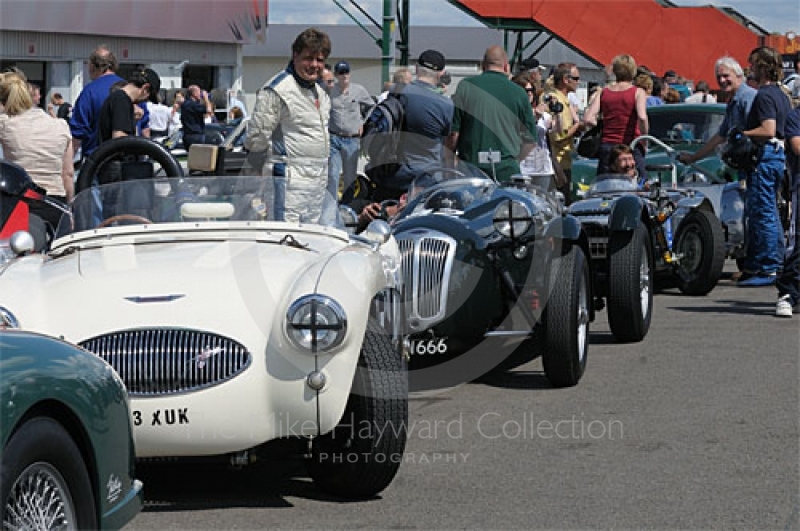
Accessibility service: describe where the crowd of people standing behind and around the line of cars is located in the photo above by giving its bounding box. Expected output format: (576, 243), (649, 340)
(0, 33), (800, 315)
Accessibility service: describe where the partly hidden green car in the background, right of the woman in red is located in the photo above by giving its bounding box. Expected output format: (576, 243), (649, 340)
(572, 103), (737, 198)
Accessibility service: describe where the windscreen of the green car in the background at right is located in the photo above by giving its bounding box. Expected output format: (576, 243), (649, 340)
(648, 105), (725, 144)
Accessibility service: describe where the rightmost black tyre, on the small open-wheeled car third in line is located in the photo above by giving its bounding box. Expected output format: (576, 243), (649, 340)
(673, 210), (725, 295)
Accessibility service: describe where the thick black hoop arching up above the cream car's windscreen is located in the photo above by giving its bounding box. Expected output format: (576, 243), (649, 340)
(75, 136), (183, 194)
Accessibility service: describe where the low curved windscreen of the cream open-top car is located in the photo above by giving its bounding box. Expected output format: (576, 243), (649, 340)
(57, 176), (318, 236)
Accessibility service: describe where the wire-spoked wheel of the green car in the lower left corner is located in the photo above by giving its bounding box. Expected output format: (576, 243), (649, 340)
(0, 417), (97, 529)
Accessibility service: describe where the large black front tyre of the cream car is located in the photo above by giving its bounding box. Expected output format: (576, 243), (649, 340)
(307, 322), (408, 499)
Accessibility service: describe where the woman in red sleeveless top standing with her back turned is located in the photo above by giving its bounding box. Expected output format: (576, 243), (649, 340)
(585, 54), (650, 176)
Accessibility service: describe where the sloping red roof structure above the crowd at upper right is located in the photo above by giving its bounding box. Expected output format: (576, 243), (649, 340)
(450, 0), (759, 84)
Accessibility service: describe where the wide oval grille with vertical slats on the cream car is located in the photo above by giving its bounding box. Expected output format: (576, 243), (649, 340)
(80, 328), (251, 396)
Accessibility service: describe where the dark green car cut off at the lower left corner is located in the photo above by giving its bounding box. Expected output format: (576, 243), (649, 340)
(0, 330), (143, 530)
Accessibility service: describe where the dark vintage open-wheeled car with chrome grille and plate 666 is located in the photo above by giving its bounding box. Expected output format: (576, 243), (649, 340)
(392, 170), (594, 389)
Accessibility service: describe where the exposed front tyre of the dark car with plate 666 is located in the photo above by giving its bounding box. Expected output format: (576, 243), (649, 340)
(542, 245), (592, 387)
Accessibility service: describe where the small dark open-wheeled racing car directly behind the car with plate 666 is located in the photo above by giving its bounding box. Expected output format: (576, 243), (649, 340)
(569, 175), (725, 342)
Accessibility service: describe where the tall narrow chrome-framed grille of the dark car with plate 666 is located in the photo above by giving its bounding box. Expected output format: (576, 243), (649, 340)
(396, 230), (456, 332)
